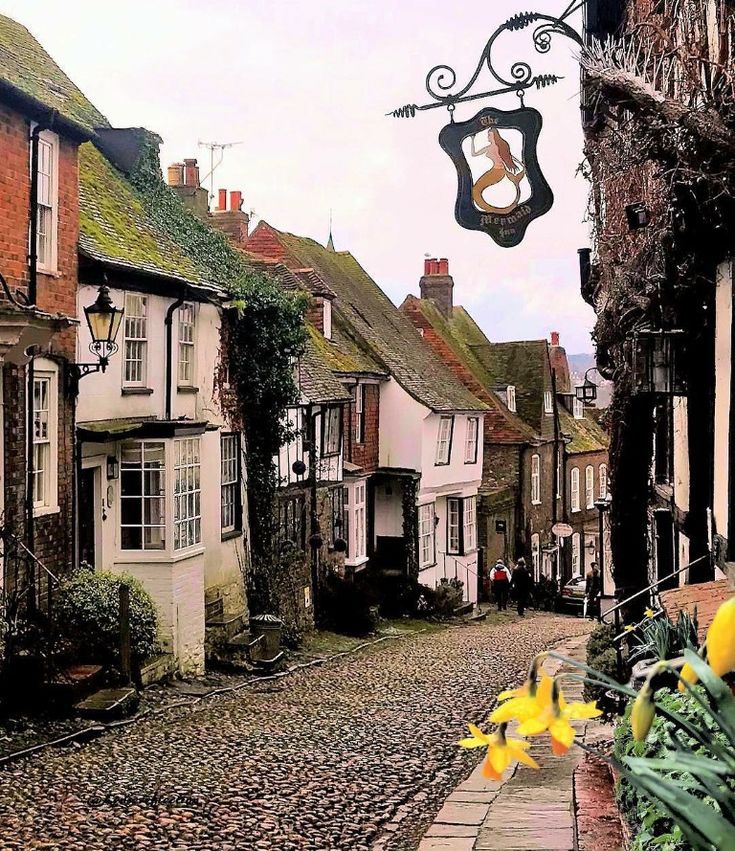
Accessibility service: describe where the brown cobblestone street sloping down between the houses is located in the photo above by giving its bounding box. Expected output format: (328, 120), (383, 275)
(0, 614), (588, 851)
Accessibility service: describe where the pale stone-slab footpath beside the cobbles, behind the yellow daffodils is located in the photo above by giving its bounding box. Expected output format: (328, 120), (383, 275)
(419, 637), (596, 851)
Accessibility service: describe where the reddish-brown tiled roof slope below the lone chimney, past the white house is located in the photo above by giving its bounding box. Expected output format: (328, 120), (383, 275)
(401, 295), (537, 443)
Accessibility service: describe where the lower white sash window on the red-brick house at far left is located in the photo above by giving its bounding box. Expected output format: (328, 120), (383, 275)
(29, 358), (59, 517)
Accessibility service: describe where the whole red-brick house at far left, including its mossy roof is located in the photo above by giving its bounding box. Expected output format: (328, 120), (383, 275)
(0, 17), (105, 609)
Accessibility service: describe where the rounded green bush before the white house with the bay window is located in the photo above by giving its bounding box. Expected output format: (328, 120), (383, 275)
(55, 568), (157, 665)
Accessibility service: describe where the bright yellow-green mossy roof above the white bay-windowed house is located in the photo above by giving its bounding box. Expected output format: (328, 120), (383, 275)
(79, 142), (223, 292)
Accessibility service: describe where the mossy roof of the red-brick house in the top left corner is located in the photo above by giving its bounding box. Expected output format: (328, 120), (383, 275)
(0, 15), (109, 133)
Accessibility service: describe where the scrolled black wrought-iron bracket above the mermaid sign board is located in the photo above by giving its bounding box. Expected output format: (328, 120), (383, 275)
(387, 6), (586, 118)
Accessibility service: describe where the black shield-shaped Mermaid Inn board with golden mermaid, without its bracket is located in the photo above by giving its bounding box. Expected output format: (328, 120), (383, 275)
(439, 107), (554, 248)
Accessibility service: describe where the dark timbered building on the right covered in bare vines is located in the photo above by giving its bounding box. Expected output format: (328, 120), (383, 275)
(581, 0), (735, 596)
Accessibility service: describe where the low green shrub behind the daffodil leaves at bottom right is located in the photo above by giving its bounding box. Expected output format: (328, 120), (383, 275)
(615, 688), (728, 851)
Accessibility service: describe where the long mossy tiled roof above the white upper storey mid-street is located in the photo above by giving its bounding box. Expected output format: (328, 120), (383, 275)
(248, 222), (486, 412)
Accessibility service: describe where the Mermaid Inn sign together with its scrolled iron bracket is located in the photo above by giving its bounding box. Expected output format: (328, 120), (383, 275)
(388, 6), (584, 248)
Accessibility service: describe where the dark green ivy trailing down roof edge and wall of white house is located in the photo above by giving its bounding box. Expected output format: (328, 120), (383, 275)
(131, 134), (306, 612)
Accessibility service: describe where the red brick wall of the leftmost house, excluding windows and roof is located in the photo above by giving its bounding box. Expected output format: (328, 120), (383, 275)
(0, 105), (79, 596)
